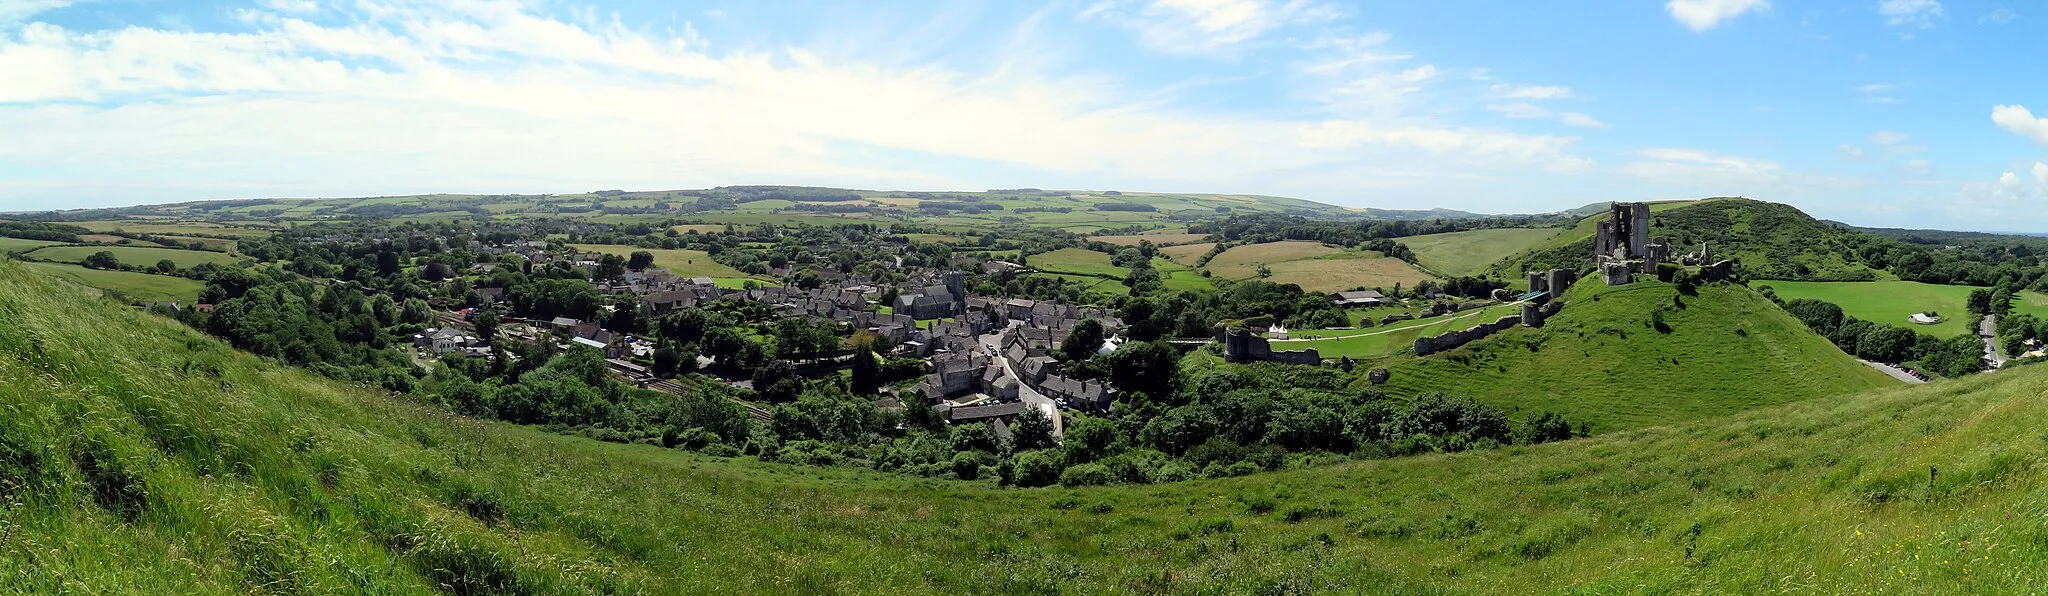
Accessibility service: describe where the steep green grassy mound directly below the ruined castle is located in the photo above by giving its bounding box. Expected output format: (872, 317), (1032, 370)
(1382, 279), (1896, 428)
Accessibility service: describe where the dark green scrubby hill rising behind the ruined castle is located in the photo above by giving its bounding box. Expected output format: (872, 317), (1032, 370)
(1489, 199), (1876, 281)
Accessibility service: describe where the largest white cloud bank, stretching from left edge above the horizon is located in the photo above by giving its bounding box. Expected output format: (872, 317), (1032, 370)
(0, 2), (1591, 203)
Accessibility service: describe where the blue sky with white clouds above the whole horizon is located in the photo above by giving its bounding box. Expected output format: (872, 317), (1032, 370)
(0, 0), (2048, 231)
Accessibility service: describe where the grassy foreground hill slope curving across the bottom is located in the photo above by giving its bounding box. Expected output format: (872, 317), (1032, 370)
(12, 262), (2048, 594)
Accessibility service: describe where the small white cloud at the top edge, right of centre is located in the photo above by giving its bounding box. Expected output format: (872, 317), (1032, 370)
(1079, 0), (1341, 55)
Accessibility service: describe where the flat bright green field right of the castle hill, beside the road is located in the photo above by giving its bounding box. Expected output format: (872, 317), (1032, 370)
(1751, 281), (2023, 338)
